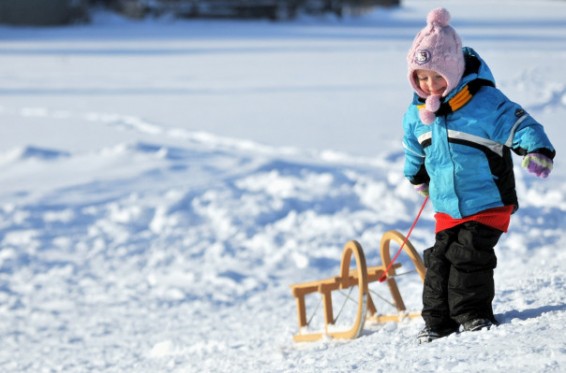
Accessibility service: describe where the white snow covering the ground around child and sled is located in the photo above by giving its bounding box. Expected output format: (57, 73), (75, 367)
(0, 0), (566, 372)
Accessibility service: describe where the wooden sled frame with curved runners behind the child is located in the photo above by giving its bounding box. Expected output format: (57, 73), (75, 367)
(291, 230), (425, 342)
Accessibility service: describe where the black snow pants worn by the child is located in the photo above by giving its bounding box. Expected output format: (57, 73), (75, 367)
(422, 222), (503, 328)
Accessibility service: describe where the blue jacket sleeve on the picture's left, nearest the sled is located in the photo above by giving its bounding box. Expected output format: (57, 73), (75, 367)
(403, 114), (430, 185)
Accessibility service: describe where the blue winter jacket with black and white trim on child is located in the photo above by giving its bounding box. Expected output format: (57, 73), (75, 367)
(403, 48), (555, 218)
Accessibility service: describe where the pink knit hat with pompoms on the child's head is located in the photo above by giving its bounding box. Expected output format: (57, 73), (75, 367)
(407, 8), (465, 124)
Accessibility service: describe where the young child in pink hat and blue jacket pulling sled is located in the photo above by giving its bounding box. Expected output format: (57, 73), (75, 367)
(403, 8), (555, 343)
